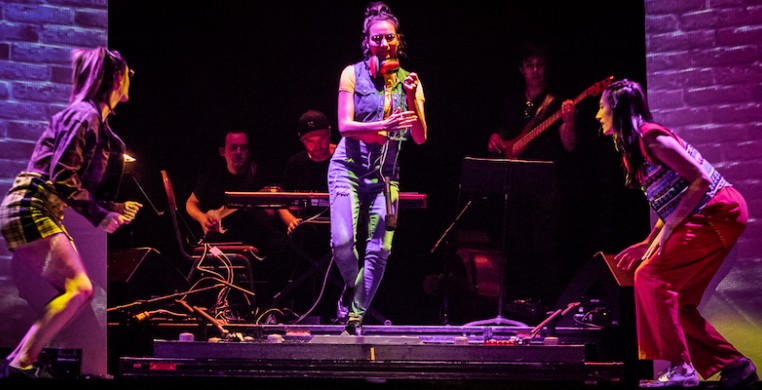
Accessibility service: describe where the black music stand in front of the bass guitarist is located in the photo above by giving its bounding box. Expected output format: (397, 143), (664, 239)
(460, 157), (553, 327)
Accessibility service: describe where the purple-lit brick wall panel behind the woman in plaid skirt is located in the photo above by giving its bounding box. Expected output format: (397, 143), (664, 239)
(0, 0), (108, 376)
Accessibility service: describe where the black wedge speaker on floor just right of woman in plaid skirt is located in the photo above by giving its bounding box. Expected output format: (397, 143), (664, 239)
(108, 248), (190, 307)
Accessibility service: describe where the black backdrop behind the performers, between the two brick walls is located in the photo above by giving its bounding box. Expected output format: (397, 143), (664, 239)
(109, 0), (648, 324)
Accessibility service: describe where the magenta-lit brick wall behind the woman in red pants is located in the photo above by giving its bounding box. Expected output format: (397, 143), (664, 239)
(645, 0), (762, 364)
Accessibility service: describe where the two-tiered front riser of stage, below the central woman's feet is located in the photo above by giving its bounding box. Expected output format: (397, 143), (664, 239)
(120, 336), (624, 383)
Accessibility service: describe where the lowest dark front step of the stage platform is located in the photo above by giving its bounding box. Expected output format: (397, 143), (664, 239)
(121, 358), (623, 384)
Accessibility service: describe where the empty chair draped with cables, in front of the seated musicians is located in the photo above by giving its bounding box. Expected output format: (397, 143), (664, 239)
(161, 170), (262, 310)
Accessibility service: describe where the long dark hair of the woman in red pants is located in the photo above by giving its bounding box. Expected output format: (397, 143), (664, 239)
(602, 79), (653, 188)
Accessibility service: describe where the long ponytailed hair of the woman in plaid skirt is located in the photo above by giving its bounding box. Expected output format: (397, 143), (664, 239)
(69, 46), (128, 107)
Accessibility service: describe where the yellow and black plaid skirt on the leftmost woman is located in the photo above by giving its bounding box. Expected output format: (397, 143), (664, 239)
(0, 172), (72, 251)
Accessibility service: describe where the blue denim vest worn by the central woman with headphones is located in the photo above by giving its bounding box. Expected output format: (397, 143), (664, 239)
(335, 60), (410, 180)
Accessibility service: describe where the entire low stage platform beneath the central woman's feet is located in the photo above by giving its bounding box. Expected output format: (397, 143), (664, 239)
(115, 324), (631, 385)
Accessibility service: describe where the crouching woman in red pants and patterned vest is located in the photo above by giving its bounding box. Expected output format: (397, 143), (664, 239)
(596, 79), (759, 387)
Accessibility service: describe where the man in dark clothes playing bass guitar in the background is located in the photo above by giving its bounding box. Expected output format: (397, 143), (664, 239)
(480, 43), (577, 313)
